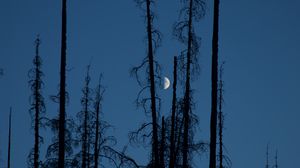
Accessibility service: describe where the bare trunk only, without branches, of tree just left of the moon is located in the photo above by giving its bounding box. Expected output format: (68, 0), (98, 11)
(146, 0), (159, 168)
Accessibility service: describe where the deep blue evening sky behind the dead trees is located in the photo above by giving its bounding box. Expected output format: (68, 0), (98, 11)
(0, 0), (300, 168)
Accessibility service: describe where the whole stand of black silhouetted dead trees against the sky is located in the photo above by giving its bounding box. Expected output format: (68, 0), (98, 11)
(0, 0), (278, 168)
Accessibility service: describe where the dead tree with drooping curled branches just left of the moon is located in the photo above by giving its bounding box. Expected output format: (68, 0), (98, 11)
(131, 0), (161, 167)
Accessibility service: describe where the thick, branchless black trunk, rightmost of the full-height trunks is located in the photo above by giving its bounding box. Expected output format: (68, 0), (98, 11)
(209, 0), (220, 168)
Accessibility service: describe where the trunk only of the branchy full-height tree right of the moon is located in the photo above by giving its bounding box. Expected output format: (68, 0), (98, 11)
(183, 0), (193, 168)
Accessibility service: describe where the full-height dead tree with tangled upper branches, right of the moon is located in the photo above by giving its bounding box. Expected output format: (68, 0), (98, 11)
(174, 0), (205, 168)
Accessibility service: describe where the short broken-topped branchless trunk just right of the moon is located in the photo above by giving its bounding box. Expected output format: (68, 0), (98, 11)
(169, 56), (177, 168)
